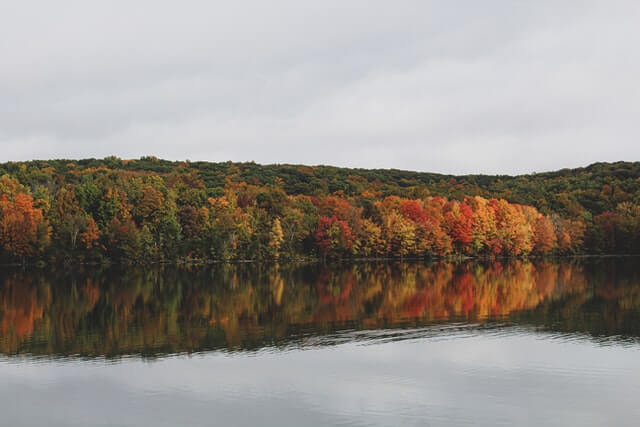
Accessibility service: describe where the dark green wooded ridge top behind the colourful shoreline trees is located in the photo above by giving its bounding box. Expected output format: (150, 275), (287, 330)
(0, 157), (640, 216)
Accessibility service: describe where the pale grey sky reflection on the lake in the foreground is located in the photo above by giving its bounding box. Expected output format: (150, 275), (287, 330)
(0, 336), (640, 426)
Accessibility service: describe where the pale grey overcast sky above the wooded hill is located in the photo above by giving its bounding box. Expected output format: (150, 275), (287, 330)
(0, 0), (640, 173)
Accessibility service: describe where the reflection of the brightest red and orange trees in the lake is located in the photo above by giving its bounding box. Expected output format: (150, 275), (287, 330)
(314, 261), (584, 323)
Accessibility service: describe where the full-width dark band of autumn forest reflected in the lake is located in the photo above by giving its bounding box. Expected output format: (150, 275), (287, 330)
(0, 258), (640, 357)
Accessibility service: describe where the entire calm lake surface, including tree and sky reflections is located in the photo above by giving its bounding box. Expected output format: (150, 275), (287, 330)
(0, 258), (640, 426)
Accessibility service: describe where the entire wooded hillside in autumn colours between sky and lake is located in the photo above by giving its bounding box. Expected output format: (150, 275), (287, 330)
(0, 157), (640, 264)
